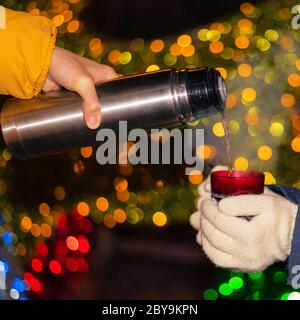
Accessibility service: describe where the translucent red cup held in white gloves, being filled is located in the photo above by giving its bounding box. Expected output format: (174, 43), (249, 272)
(210, 170), (265, 201)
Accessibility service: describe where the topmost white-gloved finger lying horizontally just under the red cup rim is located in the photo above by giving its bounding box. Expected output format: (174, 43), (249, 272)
(219, 194), (274, 216)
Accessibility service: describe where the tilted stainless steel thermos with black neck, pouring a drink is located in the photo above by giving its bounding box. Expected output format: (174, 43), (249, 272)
(1, 68), (226, 159)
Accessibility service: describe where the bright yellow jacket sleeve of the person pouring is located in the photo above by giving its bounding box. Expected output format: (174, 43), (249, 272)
(0, 9), (56, 99)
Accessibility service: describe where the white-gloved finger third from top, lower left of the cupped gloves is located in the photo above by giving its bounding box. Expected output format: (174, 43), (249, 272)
(200, 215), (233, 254)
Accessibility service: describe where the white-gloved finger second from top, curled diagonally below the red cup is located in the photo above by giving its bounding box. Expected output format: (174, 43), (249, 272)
(201, 198), (250, 238)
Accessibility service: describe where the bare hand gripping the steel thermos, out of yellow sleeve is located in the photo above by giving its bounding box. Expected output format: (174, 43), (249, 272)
(43, 47), (118, 129)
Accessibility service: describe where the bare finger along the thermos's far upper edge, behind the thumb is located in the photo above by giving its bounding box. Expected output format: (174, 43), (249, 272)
(75, 55), (118, 83)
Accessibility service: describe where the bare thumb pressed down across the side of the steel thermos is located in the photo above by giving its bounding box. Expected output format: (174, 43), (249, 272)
(76, 74), (101, 129)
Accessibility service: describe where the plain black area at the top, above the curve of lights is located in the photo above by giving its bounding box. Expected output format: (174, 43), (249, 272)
(82, 0), (258, 39)
